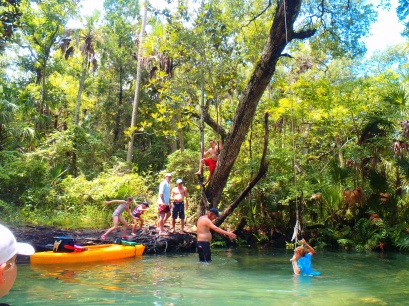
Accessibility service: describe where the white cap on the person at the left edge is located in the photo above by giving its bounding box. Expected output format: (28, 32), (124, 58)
(0, 224), (35, 264)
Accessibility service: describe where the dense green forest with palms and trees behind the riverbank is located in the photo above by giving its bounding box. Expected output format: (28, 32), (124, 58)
(0, 0), (409, 250)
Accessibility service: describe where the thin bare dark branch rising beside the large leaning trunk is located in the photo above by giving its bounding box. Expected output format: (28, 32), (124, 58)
(215, 113), (270, 226)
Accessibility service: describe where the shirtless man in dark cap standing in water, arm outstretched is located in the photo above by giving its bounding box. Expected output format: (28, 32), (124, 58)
(196, 208), (237, 262)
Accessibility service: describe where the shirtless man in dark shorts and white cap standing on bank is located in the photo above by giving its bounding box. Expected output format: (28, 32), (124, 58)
(170, 179), (189, 235)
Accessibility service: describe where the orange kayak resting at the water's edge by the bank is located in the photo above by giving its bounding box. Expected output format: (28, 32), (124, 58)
(30, 244), (145, 265)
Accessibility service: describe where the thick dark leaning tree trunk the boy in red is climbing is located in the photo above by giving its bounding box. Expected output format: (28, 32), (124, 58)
(206, 0), (315, 207)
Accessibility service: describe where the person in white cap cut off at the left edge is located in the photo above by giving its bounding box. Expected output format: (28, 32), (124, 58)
(0, 224), (35, 298)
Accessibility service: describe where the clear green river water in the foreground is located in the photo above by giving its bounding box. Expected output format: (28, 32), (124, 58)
(0, 248), (409, 306)
